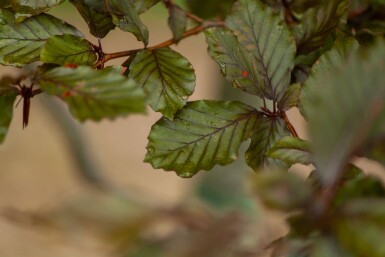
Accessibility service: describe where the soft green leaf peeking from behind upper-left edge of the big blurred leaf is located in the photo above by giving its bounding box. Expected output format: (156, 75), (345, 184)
(299, 34), (359, 117)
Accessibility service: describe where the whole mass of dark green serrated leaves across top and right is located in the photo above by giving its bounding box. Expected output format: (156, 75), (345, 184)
(0, 0), (385, 257)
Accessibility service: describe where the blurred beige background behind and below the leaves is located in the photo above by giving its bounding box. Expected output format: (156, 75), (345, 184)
(0, 1), (379, 257)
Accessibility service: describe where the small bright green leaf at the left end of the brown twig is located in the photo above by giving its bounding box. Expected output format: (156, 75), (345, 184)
(40, 34), (97, 66)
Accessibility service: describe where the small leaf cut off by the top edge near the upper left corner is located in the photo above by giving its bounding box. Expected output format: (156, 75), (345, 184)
(10, 0), (64, 15)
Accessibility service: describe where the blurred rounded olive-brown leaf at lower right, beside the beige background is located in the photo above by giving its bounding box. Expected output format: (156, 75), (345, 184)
(254, 171), (312, 211)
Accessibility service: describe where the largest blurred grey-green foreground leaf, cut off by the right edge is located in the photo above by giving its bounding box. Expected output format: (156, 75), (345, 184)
(304, 42), (385, 185)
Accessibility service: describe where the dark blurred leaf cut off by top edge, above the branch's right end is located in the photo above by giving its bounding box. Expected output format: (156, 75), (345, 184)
(186, 0), (235, 18)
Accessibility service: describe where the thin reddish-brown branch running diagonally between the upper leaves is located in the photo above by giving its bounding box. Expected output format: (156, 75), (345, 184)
(98, 21), (224, 64)
